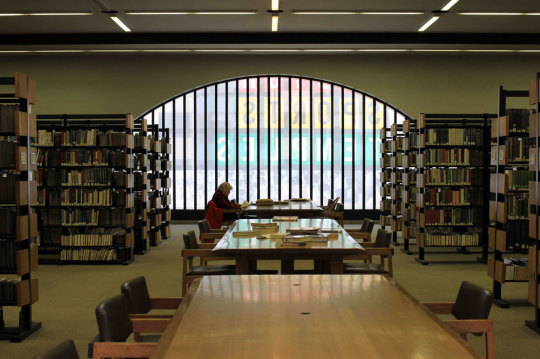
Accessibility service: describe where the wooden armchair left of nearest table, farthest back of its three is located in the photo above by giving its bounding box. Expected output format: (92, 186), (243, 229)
(120, 276), (182, 341)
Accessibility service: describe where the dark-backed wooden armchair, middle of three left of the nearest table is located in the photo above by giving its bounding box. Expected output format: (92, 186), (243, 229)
(88, 294), (170, 358)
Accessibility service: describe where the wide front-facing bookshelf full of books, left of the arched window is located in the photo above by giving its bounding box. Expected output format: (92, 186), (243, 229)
(36, 114), (134, 264)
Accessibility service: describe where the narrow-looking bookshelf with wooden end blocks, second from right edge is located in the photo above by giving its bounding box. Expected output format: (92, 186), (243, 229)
(488, 86), (533, 308)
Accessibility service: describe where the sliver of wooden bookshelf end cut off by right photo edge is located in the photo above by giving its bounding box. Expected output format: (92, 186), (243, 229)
(525, 72), (540, 334)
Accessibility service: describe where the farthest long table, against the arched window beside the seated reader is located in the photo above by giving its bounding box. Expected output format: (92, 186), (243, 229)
(245, 200), (323, 218)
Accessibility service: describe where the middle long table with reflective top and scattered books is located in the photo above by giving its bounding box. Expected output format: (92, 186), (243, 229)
(213, 218), (364, 274)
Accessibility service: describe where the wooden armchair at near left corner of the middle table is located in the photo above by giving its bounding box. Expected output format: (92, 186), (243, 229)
(182, 231), (236, 295)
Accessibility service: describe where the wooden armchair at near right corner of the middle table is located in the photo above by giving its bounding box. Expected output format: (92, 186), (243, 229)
(343, 229), (394, 277)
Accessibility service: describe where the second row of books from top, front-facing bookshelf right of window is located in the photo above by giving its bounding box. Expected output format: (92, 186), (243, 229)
(417, 148), (484, 167)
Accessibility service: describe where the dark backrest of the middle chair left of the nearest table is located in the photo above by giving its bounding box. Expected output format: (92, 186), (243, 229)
(96, 294), (133, 342)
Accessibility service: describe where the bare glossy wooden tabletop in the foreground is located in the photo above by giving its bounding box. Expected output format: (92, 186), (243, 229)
(151, 275), (482, 359)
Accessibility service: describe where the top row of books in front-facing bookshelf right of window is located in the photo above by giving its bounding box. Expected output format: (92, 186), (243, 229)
(426, 128), (484, 146)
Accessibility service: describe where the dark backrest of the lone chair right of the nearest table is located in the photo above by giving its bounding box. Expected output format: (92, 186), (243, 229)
(452, 281), (493, 319)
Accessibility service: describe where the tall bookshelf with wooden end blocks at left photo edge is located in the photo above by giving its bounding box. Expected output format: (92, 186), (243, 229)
(0, 73), (41, 342)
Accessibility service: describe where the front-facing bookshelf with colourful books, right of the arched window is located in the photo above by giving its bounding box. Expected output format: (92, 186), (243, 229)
(416, 114), (489, 265)
